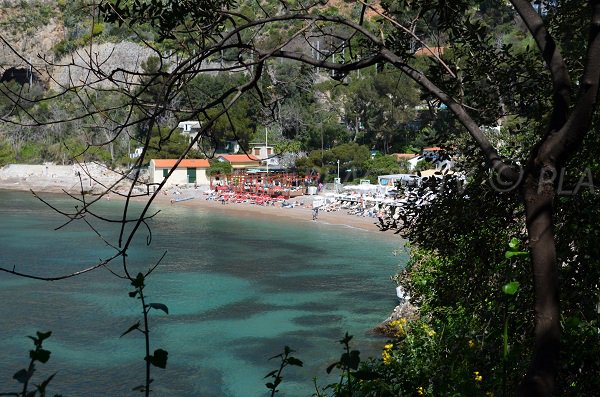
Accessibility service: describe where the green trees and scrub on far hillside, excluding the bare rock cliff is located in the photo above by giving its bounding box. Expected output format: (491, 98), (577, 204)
(0, 0), (432, 167)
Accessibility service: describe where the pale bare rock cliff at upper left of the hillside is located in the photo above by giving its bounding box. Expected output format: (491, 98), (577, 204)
(0, 0), (152, 90)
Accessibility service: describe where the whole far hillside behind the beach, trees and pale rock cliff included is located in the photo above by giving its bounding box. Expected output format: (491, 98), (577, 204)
(0, 0), (432, 172)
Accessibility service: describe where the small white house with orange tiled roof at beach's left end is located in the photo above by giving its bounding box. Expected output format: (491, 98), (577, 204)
(148, 159), (210, 186)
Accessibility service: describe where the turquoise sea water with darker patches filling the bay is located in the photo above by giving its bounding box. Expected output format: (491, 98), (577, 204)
(0, 191), (405, 397)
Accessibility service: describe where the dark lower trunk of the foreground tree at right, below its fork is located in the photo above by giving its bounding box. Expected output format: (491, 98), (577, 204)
(518, 170), (560, 397)
